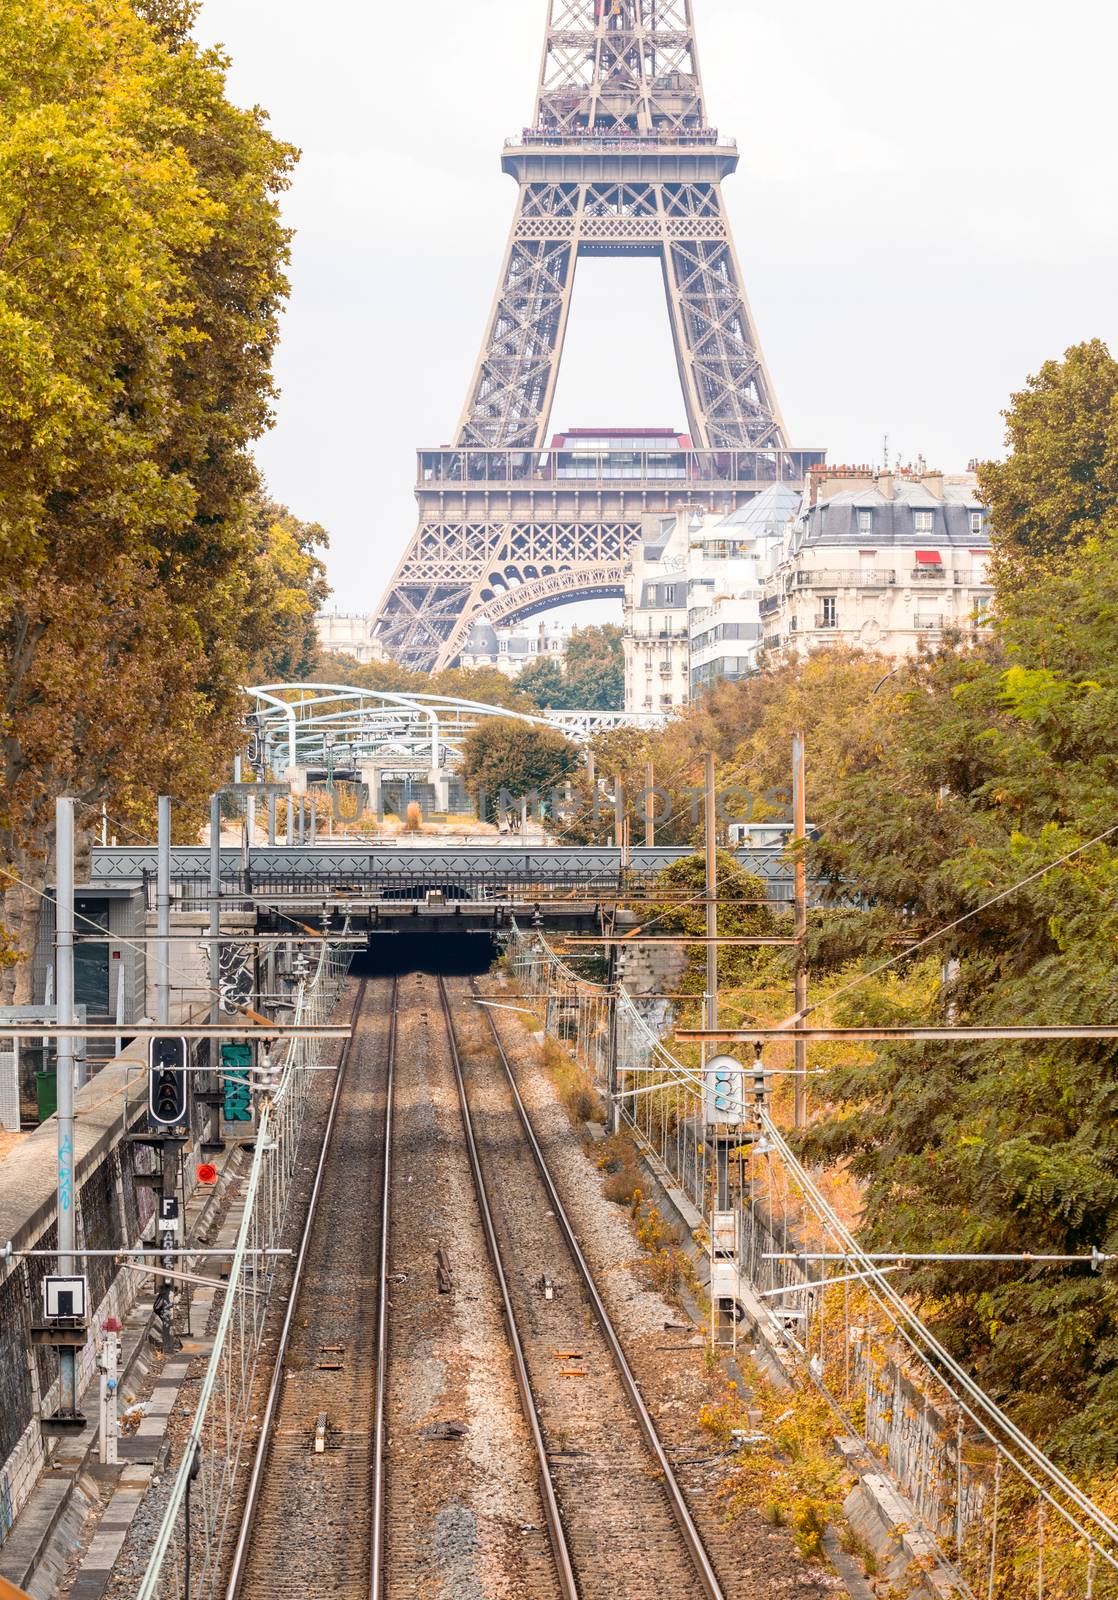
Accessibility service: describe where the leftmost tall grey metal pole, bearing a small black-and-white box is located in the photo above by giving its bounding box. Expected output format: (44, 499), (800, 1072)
(54, 797), (80, 1421)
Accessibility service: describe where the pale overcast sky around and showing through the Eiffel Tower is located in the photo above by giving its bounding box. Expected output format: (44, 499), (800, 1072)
(200, 0), (1118, 611)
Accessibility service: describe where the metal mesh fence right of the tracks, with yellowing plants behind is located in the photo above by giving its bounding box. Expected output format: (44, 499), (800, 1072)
(509, 930), (1118, 1600)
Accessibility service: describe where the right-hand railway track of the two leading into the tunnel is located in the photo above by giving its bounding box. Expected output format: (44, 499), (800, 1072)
(440, 979), (723, 1600)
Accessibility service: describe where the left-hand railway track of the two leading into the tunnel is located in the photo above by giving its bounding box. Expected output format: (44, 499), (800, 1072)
(227, 979), (395, 1600)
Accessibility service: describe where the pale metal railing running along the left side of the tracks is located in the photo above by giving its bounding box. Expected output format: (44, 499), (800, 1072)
(136, 946), (349, 1600)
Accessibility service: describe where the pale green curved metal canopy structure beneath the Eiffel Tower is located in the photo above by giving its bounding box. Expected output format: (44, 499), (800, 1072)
(245, 683), (662, 773)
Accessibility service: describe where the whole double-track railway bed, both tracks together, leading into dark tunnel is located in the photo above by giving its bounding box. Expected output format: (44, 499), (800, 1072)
(227, 974), (723, 1600)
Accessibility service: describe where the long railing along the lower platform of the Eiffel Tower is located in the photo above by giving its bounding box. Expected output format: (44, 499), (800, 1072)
(417, 446), (825, 490)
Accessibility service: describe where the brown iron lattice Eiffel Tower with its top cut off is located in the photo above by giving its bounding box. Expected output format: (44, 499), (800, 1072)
(373, 0), (822, 670)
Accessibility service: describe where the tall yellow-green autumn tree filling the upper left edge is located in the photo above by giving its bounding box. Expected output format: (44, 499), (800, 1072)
(0, 0), (297, 992)
